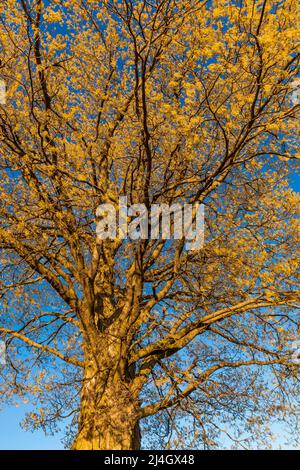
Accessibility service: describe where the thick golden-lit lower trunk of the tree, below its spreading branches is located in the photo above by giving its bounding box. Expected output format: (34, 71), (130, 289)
(72, 341), (140, 450)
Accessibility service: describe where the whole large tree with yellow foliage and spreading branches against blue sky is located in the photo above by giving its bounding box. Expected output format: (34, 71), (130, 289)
(0, 0), (299, 449)
